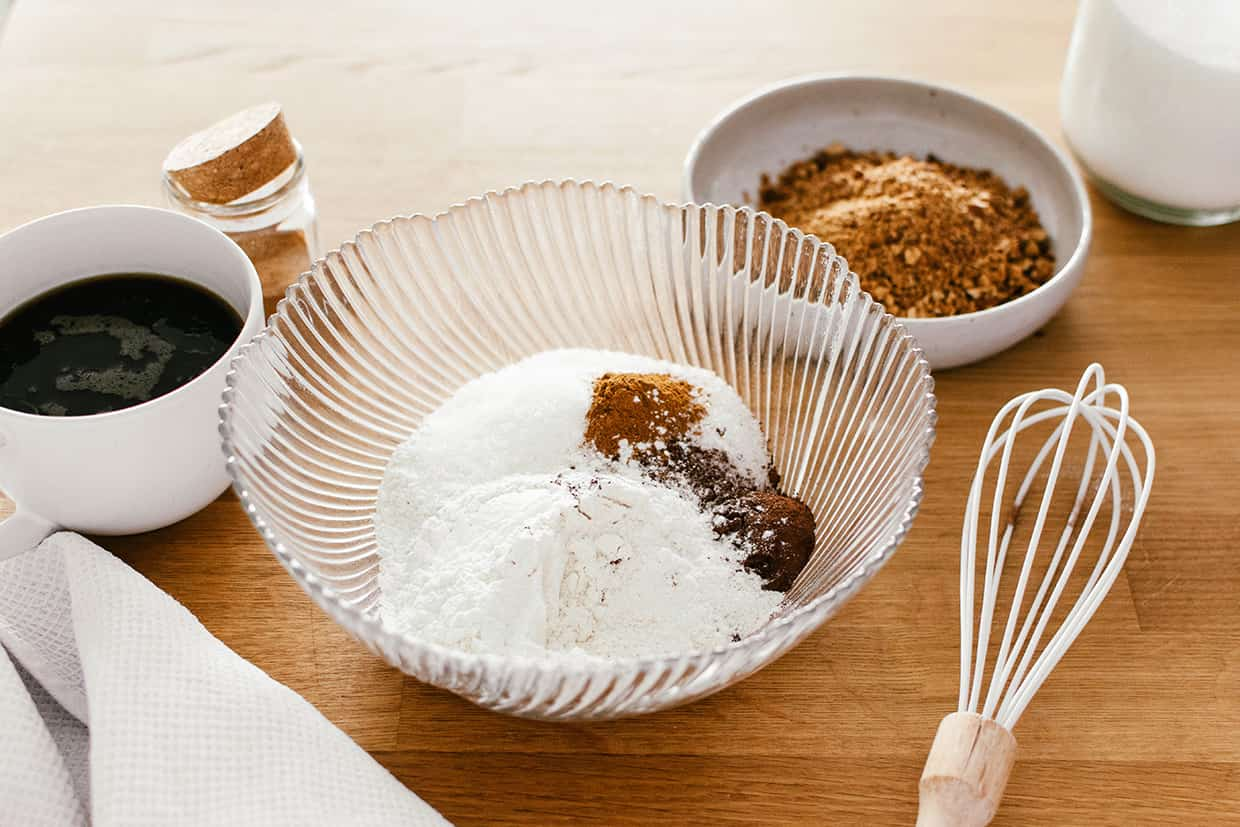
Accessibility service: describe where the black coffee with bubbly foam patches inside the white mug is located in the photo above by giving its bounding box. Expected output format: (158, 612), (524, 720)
(0, 273), (242, 417)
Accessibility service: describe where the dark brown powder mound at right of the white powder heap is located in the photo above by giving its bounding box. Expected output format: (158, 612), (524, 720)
(714, 491), (815, 591)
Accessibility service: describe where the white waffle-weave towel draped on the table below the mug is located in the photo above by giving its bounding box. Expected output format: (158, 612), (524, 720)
(0, 532), (448, 827)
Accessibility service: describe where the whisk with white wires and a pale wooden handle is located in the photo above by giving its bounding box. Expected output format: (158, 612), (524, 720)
(918, 363), (1154, 827)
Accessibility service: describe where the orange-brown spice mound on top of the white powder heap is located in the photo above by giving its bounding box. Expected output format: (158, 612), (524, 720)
(585, 373), (706, 459)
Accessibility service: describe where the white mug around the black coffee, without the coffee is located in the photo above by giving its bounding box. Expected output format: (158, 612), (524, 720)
(0, 206), (263, 559)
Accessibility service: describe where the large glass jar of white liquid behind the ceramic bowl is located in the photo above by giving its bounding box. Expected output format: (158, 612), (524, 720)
(1060, 0), (1240, 226)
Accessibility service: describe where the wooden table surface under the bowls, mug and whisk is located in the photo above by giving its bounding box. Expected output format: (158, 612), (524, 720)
(0, 0), (1240, 827)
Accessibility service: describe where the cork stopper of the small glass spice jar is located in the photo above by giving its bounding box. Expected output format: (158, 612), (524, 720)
(164, 103), (298, 203)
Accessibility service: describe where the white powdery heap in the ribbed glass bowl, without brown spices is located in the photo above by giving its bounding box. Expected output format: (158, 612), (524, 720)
(374, 350), (781, 657)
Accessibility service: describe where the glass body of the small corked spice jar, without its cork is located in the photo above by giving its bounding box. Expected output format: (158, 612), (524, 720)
(164, 141), (319, 314)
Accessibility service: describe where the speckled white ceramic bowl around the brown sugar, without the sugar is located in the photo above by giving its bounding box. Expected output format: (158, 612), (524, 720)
(683, 76), (1091, 369)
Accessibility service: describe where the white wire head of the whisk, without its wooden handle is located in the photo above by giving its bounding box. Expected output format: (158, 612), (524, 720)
(957, 363), (1154, 729)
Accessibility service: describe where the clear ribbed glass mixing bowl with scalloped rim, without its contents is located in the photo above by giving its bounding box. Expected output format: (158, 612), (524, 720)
(219, 181), (935, 720)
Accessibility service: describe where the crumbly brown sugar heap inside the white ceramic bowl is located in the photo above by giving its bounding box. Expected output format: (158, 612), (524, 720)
(759, 144), (1055, 319)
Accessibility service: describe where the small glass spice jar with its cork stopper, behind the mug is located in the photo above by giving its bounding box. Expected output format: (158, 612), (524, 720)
(164, 104), (319, 314)
